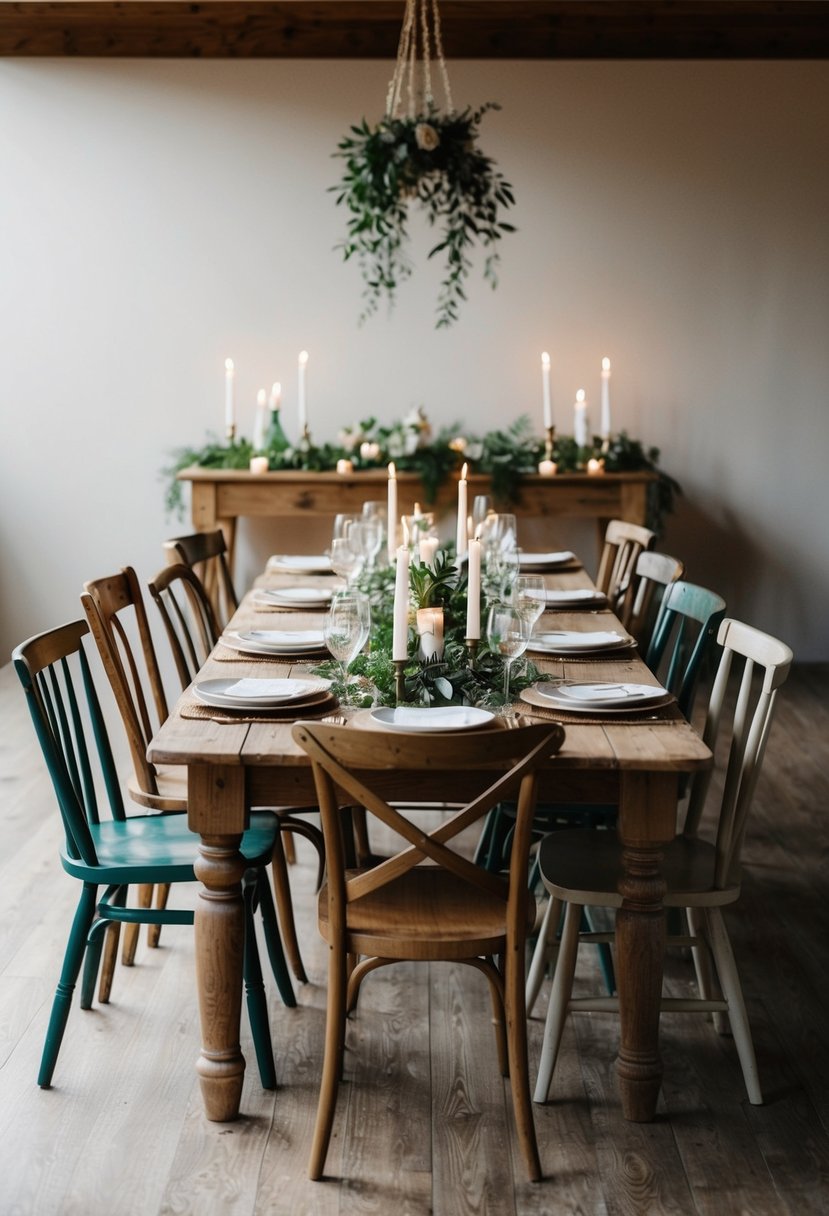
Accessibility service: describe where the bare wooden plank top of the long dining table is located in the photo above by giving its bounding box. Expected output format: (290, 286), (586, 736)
(148, 559), (711, 772)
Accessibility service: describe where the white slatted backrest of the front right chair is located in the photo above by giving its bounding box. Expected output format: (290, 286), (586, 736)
(684, 618), (793, 888)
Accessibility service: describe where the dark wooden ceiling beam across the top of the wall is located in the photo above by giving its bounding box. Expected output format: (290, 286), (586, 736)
(0, 0), (829, 60)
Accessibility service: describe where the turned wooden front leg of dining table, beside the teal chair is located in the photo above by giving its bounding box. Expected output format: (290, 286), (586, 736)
(187, 765), (246, 1122)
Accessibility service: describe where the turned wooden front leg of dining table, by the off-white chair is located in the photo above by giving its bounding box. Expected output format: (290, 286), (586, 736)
(616, 772), (677, 1122)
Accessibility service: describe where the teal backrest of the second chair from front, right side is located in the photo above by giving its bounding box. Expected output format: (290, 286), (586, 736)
(644, 579), (726, 719)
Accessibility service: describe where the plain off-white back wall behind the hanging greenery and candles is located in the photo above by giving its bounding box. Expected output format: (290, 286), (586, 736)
(0, 60), (829, 660)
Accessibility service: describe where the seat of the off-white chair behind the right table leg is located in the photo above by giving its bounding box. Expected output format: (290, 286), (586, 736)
(538, 831), (739, 907)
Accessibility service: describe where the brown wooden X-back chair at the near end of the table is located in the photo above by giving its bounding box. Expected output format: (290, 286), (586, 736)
(293, 722), (564, 1180)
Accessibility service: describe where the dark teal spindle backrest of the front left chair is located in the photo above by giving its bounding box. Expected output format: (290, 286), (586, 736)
(12, 620), (124, 865)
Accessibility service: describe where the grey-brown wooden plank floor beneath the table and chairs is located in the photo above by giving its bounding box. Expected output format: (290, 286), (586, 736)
(0, 666), (829, 1216)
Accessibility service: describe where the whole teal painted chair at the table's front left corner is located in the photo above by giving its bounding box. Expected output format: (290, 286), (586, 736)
(12, 620), (285, 1090)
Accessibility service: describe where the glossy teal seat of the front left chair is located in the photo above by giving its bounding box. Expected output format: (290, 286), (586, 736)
(61, 811), (280, 884)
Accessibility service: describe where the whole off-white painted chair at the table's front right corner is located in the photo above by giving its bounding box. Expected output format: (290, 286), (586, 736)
(525, 619), (793, 1104)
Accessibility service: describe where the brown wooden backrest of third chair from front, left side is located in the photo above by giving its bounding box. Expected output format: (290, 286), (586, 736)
(150, 563), (220, 689)
